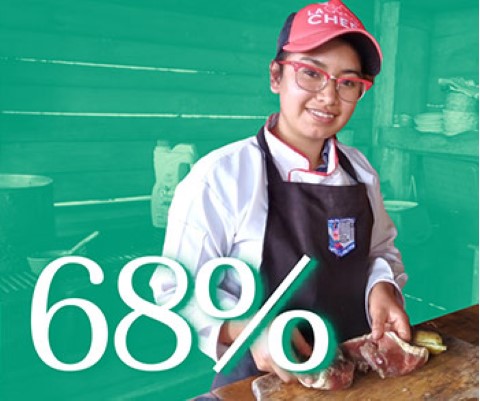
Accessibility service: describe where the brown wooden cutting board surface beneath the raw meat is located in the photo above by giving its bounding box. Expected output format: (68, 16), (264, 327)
(214, 336), (479, 401)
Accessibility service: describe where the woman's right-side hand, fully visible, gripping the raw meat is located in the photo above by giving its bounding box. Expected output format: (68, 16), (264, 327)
(368, 282), (411, 342)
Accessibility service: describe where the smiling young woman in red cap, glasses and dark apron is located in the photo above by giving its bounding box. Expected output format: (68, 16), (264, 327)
(151, 0), (410, 387)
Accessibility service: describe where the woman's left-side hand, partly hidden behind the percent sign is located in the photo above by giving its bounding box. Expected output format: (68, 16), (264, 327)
(220, 321), (312, 383)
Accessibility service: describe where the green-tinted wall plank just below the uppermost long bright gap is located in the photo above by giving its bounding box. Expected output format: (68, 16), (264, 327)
(0, 57), (268, 97)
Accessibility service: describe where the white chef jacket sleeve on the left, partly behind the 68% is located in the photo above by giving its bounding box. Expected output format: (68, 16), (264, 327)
(150, 170), (240, 360)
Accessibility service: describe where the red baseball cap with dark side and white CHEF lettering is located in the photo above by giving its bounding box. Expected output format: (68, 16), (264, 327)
(277, 0), (382, 76)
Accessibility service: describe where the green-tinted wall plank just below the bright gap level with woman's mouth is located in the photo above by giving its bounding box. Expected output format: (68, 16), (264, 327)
(0, 114), (262, 145)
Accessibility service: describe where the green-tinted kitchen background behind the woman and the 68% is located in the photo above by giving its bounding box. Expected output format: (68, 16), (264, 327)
(0, 0), (479, 400)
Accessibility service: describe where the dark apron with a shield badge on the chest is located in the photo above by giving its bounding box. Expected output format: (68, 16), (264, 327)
(212, 128), (373, 388)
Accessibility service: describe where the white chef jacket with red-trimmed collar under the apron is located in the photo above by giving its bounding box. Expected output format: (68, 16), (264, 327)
(150, 115), (407, 360)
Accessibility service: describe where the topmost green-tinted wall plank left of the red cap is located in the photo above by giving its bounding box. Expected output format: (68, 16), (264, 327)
(0, 0), (278, 50)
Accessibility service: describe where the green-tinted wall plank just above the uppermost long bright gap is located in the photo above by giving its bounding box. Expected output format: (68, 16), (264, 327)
(0, 27), (275, 75)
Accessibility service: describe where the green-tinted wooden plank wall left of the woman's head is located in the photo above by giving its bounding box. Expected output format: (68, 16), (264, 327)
(0, 0), (371, 234)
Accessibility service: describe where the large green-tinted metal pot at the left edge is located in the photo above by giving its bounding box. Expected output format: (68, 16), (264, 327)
(0, 174), (55, 273)
